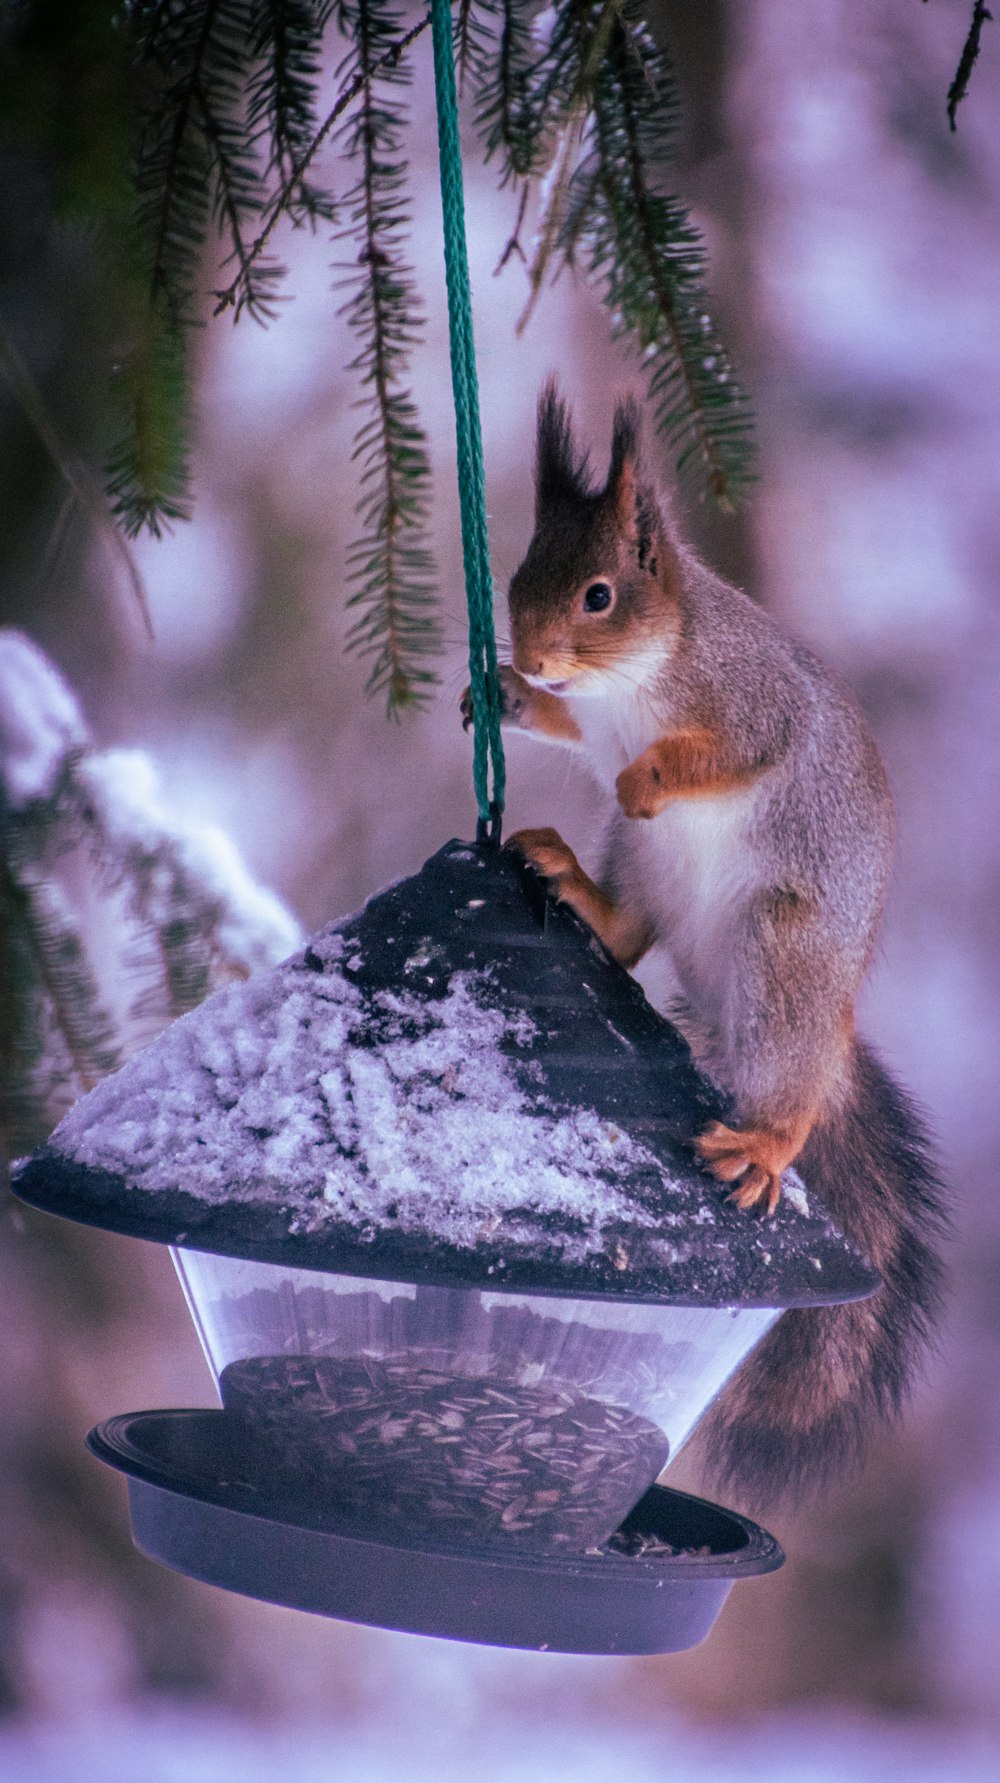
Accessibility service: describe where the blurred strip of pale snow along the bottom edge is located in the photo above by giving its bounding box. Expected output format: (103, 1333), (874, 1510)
(0, 1697), (998, 1783)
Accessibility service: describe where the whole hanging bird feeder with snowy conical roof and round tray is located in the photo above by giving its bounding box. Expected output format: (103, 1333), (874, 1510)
(14, 842), (879, 1653)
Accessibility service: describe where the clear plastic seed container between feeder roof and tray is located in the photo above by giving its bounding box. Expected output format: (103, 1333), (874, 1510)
(173, 1250), (779, 1553)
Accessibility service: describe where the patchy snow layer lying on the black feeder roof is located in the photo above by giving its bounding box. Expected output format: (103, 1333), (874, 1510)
(52, 955), (663, 1261)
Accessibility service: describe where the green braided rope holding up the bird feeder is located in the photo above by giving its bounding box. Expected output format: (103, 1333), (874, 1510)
(431, 0), (506, 842)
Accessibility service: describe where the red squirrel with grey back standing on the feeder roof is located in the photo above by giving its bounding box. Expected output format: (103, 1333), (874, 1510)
(462, 382), (947, 1505)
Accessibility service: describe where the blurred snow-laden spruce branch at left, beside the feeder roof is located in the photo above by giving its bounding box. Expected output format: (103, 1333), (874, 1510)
(0, 631), (299, 1157)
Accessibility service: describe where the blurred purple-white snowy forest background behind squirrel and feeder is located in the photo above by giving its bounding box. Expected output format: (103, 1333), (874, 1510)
(0, 0), (1000, 1783)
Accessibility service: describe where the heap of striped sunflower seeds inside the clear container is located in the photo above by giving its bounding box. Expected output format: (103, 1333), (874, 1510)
(221, 1352), (667, 1553)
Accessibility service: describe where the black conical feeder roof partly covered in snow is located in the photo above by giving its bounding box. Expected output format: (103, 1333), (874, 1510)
(14, 842), (877, 1307)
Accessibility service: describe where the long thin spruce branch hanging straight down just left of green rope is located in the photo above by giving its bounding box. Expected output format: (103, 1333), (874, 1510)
(339, 0), (439, 715)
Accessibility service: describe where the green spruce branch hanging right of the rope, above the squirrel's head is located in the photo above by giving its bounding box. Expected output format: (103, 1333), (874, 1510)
(474, 0), (752, 506)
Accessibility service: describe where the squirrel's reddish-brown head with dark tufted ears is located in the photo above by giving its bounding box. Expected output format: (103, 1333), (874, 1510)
(508, 382), (679, 694)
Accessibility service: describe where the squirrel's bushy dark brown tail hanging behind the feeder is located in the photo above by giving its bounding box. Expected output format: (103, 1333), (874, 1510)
(699, 1045), (948, 1510)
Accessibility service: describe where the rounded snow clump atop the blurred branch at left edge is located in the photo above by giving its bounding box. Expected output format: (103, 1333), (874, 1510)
(0, 631), (87, 811)
